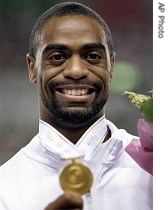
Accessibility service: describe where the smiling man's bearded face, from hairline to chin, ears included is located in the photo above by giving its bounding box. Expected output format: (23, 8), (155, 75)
(26, 16), (114, 124)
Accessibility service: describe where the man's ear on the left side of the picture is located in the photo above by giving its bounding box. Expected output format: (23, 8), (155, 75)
(26, 53), (37, 84)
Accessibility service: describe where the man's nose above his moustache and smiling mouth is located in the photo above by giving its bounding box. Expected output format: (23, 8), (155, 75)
(63, 55), (89, 80)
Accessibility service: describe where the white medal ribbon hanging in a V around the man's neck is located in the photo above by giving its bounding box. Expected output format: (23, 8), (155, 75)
(39, 115), (107, 161)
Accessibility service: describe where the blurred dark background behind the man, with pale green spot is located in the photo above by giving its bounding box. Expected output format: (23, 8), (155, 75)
(0, 0), (153, 165)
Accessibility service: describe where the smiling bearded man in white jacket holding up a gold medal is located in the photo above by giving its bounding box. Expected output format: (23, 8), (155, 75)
(0, 2), (152, 210)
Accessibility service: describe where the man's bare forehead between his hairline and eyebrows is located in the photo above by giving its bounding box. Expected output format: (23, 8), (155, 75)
(41, 15), (106, 45)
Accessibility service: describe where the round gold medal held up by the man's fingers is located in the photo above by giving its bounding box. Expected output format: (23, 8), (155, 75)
(60, 160), (93, 195)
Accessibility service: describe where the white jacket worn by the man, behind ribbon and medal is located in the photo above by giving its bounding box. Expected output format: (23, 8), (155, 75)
(0, 120), (153, 210)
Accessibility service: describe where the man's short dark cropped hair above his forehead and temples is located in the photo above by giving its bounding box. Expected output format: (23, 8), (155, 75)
(29, 2), (113, 58)
